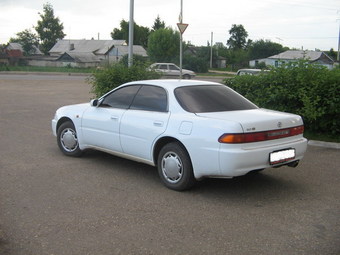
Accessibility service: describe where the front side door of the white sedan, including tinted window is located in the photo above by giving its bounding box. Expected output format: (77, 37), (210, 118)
(82, 85), (140, 152)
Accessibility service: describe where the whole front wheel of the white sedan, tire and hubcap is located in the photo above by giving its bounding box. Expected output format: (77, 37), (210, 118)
(57, 121), (82, 157)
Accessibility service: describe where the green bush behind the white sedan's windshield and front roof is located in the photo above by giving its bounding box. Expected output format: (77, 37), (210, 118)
(88, 64), (160, 97)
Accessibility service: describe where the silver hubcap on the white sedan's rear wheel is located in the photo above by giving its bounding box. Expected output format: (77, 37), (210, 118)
(162, 152), (183, 183)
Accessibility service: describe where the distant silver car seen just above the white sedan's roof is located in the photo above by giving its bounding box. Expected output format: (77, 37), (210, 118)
(150, 63), (196, 79)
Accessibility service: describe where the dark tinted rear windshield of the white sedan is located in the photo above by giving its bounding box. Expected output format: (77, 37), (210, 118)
(175, 85), (258, 113)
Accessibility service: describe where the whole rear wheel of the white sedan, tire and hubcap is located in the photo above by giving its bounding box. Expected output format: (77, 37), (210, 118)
(157, 143), (196, 191)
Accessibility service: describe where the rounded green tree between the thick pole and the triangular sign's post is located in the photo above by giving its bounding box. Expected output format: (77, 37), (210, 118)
(148, 28), (180, 62)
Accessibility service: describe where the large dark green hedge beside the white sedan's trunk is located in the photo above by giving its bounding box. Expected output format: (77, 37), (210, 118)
(225, 61), (340, 135)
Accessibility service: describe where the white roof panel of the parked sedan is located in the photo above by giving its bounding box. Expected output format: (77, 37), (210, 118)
(122, 79), (220, 90)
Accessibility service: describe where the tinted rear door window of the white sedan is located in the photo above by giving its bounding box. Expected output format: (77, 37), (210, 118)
(130, 85), (168, 112)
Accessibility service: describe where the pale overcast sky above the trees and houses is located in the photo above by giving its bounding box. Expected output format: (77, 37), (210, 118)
(0, 0), (340, 51)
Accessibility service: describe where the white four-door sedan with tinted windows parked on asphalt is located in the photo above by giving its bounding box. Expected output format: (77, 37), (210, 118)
(52, 80), (307, 190)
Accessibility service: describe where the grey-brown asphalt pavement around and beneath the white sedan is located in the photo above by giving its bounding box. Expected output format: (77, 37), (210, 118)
(0, 74), (340, 255)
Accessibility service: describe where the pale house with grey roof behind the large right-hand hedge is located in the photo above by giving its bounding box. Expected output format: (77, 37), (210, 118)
(249, 50), (334, 69)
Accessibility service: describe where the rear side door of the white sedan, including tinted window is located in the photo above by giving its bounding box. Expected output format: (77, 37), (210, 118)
(120, 85), (170, 160)
